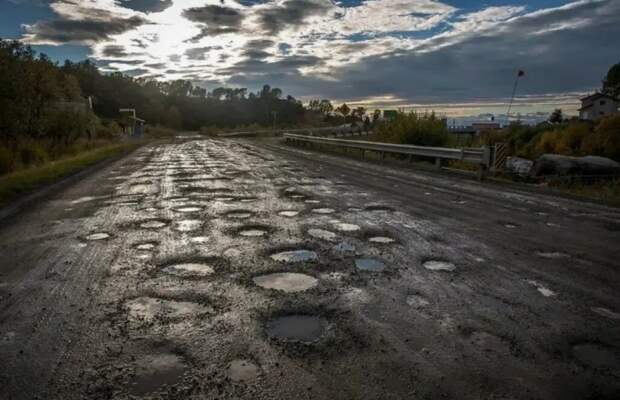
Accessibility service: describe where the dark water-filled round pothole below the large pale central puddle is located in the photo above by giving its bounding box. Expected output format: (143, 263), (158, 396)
(265, 315), (328, 344)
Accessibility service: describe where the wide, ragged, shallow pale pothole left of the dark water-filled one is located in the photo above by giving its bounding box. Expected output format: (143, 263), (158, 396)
(125, 297), (209, 322)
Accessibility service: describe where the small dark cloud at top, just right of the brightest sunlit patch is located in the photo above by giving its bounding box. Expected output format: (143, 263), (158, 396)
(183, 5), (244, 42)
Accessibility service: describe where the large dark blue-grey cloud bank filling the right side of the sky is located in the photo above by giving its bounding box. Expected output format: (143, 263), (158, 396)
(228, 0), (620, 103)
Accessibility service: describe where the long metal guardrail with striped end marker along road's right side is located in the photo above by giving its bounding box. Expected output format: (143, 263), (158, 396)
(283, 133), (491, 179)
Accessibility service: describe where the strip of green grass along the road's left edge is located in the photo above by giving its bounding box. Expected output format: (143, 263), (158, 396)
(0, 143), (139, 205)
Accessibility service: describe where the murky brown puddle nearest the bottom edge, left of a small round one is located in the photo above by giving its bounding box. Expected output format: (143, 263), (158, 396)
(129, 353), (187, 396)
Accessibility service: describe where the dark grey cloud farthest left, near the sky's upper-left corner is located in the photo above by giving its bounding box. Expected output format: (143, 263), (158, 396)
(25, 8), (147, 44)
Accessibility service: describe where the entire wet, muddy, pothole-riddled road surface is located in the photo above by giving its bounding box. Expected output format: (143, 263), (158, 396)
(0, 140), (620, 399)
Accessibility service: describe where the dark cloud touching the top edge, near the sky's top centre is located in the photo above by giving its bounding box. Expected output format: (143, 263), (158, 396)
(259, 0), (333, 35)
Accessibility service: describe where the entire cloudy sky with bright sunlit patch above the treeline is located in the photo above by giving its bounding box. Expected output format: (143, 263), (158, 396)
(0, 0), (620, 118)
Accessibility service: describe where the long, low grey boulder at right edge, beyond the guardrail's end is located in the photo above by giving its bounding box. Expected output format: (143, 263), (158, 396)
(530, 154), (620, 176)
